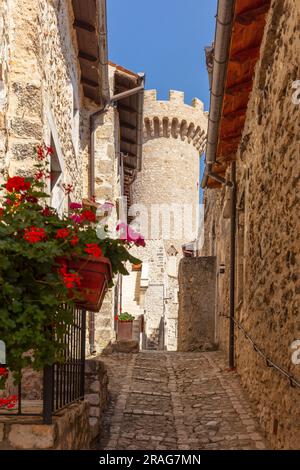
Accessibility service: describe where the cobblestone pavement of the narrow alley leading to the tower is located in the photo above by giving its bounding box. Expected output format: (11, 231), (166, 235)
(99, 351), (267, 450)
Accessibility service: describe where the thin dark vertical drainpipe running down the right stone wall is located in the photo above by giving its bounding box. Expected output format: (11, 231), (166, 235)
(229, 162), (236, 369)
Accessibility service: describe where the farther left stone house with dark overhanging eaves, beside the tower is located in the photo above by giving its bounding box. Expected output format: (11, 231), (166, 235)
(88, 63), (144, 354)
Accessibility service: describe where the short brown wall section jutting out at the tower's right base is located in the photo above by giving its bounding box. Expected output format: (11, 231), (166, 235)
(178, 256), (216, 351)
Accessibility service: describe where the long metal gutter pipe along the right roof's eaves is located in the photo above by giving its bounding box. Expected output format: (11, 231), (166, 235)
(201, 0), (235, 189)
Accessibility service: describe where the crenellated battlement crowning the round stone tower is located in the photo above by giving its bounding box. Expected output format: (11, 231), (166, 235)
(144, 90), (207, 152)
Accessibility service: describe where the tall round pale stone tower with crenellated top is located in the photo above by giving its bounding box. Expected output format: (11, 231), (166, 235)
(122, 90), (207, 350)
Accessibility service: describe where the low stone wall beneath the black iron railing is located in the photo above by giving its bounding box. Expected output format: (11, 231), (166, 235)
(0, 359), (108, 450)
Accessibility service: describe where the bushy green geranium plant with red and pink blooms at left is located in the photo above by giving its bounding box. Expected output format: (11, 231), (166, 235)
(0, 145), (140, 387)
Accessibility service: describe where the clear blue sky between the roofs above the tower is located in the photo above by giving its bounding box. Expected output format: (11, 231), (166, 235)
(107, 0), (217, 197)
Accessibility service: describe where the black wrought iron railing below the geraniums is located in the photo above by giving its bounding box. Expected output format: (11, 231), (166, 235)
(0, 309), (86, 424)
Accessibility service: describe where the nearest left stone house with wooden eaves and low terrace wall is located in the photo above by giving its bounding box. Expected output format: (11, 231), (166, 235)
(0, 0), (109, 449)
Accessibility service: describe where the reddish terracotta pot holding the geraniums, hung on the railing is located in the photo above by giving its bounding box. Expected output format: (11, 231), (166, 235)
(57, 257), (112, 312)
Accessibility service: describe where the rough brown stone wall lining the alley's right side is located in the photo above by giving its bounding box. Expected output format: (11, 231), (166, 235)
(202, 0), (300, 449)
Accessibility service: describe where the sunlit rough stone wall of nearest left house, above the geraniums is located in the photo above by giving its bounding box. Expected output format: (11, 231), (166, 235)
(0, 0), (95, 200)
